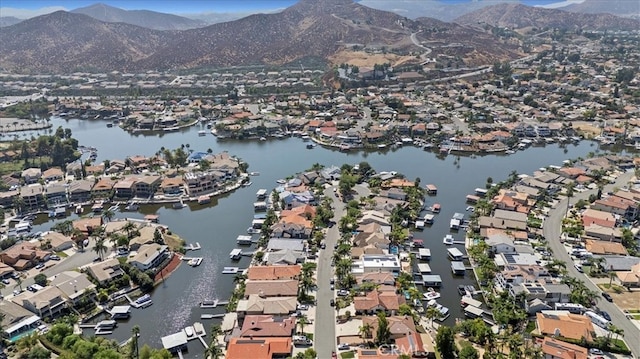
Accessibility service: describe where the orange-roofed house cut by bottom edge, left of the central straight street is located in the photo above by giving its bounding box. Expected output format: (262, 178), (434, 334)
(225, 337), (293, 359)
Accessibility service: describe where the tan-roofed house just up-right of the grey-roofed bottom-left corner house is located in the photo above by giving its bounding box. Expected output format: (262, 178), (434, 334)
(11, 286), (67, 318)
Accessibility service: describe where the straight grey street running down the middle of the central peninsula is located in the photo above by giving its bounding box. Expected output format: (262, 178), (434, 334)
(313, 186), (344, 358)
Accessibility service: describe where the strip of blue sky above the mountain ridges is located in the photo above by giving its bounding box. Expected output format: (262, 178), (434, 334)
(0, 0), (579, 17)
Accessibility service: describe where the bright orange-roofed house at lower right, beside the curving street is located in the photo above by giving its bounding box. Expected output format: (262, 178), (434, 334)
(536, 311), (594, 341)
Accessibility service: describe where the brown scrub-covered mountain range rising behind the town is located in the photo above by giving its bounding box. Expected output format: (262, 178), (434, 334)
(0, 0), (640, 73)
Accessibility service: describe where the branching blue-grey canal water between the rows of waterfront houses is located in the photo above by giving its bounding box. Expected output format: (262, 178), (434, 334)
(20, 117), (608, 357)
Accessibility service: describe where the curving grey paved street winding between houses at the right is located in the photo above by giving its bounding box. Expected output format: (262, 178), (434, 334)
(543, 172), (640, 358)
